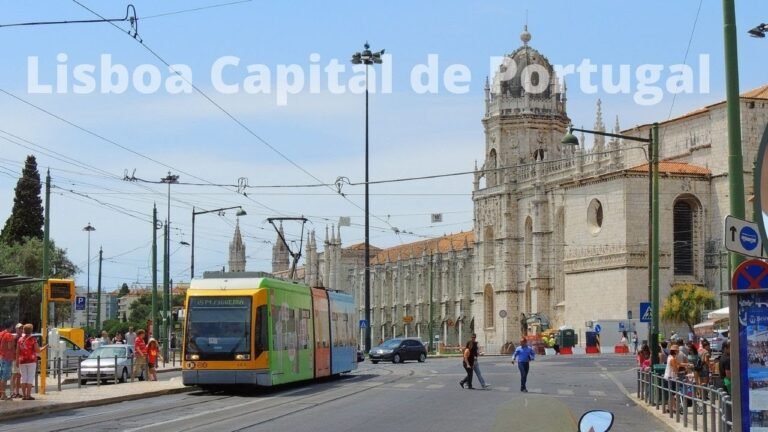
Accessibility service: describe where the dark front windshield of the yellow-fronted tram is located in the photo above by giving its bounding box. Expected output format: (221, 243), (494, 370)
(185, 297), (251, 360)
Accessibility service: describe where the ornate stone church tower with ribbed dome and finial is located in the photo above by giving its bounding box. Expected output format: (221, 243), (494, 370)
(472, 26), (572, 351)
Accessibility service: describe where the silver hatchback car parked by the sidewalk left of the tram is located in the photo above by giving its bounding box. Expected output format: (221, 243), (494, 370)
(80, 344), (147, 384)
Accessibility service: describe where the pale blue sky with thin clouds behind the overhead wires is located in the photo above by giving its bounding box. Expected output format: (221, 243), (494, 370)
(0, 0), (768, 290)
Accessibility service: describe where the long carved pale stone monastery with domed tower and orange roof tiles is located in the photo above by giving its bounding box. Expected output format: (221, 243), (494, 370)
(273, 31), (768, 352)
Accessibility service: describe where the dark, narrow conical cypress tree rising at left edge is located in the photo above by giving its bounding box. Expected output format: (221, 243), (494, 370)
(0, 155), (44, 245)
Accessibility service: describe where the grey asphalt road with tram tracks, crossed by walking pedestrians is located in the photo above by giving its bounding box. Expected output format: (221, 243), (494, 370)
(0, 356), (669, 432)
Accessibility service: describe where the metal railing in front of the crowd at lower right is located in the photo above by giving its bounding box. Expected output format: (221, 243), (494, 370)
(637, 369), (733, 432)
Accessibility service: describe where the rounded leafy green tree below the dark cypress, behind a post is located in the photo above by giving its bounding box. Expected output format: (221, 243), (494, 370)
(0, 238), (79, 329)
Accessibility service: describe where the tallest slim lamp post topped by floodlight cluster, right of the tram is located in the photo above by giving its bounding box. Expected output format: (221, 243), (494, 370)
(352, 42), (384, 352)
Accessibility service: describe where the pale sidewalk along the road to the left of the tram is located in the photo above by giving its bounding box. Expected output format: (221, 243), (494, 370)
(0, 363), (190, 424)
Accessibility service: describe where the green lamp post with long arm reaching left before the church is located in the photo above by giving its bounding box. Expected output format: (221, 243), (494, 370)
(561, 123), (660, 364)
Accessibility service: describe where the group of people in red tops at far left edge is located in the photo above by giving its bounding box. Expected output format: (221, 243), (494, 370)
(0, 321), (48, 400)
